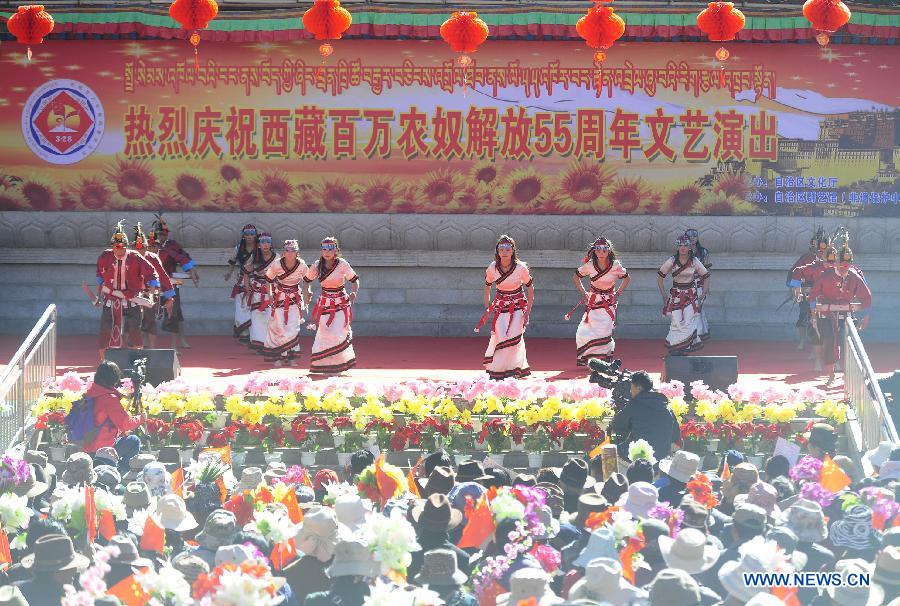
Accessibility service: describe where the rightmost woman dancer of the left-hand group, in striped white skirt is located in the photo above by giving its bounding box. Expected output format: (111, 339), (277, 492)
(304, 238), (359, 374)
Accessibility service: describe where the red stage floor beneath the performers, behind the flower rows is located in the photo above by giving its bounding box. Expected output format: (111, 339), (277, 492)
(0, 335), (900, 393)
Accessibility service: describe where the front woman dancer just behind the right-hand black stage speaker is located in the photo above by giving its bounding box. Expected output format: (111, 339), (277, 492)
(656, 236), (709, 356)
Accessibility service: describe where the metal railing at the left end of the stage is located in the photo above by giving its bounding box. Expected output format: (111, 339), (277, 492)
(0, 304), (57, 447)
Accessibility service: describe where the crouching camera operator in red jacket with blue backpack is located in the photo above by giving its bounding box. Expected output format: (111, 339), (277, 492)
(84, 360), (146, 471)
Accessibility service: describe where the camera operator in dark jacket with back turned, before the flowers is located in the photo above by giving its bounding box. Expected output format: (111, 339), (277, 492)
(609, 371), (681, 460)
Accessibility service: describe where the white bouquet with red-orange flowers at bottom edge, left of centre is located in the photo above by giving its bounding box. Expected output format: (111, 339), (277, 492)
(193, 560), (281, 606)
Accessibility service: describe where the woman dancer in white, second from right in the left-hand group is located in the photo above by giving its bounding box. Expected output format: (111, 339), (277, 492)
(261, 240), (312, 366)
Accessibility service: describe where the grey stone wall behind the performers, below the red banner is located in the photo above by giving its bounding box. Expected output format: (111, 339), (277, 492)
(0, 212), (900, 340)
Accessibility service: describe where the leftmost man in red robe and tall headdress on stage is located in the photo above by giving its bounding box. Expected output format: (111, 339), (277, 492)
(94, 226), (160, 360)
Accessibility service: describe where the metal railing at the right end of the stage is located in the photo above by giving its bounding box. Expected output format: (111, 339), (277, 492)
(842, 318), (898, 454)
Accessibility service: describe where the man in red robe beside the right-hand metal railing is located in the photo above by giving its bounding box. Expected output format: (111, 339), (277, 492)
(809, 245), (872, 385)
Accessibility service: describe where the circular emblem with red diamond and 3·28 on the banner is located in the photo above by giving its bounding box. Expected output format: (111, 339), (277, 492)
(22, 80), (106, 164)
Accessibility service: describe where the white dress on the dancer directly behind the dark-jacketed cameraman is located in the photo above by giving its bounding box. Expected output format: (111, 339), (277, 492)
(575, 258), (628, 365)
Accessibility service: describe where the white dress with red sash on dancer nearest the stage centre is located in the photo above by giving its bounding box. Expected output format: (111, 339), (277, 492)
(484, 261), (534, 380)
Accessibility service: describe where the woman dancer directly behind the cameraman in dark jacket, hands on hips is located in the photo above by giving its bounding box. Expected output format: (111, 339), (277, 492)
(572, 238), (631, 366)
